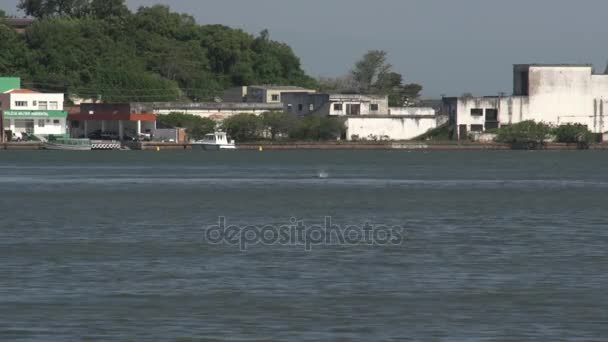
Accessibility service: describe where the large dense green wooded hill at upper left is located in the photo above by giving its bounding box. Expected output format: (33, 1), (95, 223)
(0, 0), (316, 102)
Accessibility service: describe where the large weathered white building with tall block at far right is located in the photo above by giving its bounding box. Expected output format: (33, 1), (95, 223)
(442, 64), (608, 139)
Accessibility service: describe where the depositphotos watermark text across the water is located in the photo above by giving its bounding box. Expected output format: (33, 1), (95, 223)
(205, 216), (405, 251)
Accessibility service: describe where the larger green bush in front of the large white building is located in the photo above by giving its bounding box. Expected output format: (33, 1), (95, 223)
(496, 120), (552, 148)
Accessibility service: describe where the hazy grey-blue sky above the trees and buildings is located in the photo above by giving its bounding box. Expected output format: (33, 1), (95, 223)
(0, 0), (608, 98)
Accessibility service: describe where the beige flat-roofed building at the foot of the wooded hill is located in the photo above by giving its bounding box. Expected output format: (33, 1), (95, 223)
(222, 85), (316, 103)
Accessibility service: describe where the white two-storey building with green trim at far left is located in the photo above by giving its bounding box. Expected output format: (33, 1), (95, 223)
(0, 89), (68, 140)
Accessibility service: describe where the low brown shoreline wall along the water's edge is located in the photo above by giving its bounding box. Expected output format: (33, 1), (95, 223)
(0, 141), (608, 151)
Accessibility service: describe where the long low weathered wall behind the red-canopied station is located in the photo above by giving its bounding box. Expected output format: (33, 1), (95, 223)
(131, 102), (283, 121)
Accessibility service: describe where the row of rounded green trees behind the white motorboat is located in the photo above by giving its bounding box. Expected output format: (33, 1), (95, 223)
(222, 112), (346, 142)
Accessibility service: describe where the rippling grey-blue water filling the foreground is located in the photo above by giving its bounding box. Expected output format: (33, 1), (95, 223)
(0, 151), (608, 341)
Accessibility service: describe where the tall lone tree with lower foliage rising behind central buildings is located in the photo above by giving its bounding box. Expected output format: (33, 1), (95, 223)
(319, 50), (422, 107)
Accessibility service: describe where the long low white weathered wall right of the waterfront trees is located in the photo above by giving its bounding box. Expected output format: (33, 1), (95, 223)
(346, 116), (437, 140)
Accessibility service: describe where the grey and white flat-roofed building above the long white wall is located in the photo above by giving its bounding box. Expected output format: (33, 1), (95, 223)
(283, 93), (389, 116)
